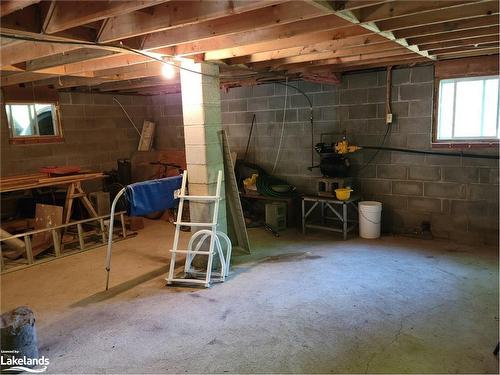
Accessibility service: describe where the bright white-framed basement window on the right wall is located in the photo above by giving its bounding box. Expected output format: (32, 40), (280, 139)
(436, 76), (500, 142)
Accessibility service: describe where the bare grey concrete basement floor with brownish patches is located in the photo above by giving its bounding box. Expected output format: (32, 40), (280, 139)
(1, 221), (499, 373)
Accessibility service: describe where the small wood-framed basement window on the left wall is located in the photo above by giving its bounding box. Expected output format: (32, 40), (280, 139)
(5, 103), (62, 143)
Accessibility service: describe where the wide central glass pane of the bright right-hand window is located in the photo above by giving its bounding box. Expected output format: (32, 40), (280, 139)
(454, 80), (483, 138)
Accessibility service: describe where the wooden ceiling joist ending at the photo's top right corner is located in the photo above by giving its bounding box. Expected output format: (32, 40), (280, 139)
(377, 0), (499, 31)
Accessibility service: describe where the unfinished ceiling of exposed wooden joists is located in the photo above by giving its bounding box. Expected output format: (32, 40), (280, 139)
(0, 0), (499, 94)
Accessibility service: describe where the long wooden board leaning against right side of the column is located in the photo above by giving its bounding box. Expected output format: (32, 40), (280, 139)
(221, 130), (250, 254)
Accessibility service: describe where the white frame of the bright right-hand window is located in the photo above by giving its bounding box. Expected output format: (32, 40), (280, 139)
(434, 75), (500, 143)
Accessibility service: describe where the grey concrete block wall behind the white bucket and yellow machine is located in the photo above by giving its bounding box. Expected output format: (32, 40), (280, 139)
(222, 66), (499, 244)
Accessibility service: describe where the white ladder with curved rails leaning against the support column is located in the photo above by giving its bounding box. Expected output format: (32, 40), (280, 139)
(167, 171), (231, 288)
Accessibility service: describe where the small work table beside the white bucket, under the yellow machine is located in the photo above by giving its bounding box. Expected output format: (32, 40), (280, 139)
(302, 195), (359, 240)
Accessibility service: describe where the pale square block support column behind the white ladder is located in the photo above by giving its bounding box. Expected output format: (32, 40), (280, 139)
(180, 62), (227, 233)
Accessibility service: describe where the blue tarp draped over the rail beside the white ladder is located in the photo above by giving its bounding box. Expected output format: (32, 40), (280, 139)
(125, 176), (182, 216)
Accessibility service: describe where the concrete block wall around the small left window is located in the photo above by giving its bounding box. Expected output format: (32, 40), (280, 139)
(1, 92), (156, 176)
